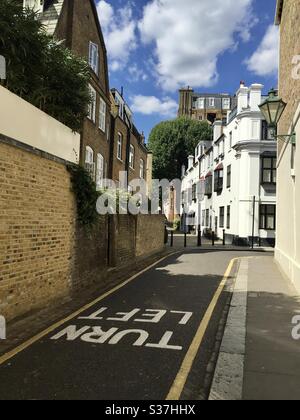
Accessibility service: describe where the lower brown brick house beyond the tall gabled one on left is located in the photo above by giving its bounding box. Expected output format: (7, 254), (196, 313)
(110, 89), (152, 191)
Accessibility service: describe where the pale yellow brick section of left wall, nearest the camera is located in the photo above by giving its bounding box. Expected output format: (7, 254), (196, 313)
(0, 142), (75, 319)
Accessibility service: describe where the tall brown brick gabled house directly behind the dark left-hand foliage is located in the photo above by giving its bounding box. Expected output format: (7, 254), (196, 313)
(23, 0), (110, 188)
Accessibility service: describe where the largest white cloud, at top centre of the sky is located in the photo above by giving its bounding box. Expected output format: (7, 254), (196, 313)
(139, 0), (256, 90)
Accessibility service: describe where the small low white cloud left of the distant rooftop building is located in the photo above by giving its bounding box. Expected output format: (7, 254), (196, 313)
(130, 95), (178, 118)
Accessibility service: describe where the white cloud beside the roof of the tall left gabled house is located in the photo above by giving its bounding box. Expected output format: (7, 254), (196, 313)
(97, 0), (137, 71)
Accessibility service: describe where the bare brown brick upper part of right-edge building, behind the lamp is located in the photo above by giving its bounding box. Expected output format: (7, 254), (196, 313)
(278, 0), (300, 148)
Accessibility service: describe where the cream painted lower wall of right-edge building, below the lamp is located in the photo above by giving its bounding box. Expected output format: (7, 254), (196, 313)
(275, 105), (300, 292)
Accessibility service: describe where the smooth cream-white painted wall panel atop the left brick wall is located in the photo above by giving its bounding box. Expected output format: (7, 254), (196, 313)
(0, 86), (80, 163)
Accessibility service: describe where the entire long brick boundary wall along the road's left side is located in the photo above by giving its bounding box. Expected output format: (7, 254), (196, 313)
(0, 135), (164, 319)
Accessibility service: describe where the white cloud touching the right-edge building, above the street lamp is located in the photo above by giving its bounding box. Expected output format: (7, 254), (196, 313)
(246, 25), (279, 76)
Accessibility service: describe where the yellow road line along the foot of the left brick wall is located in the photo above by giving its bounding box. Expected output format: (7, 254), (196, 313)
(0, 251), (180, 365)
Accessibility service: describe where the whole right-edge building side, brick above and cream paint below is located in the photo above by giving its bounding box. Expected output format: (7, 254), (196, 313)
(275, 0), (300, 290)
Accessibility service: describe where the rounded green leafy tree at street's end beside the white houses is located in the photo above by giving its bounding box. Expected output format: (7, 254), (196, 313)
(149, 117), (212, 180)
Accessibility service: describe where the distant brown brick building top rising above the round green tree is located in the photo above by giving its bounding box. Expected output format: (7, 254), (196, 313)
(178, 87), (236, 124)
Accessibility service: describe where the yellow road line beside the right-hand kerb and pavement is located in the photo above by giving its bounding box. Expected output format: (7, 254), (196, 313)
(166, 258), (239, 401)
